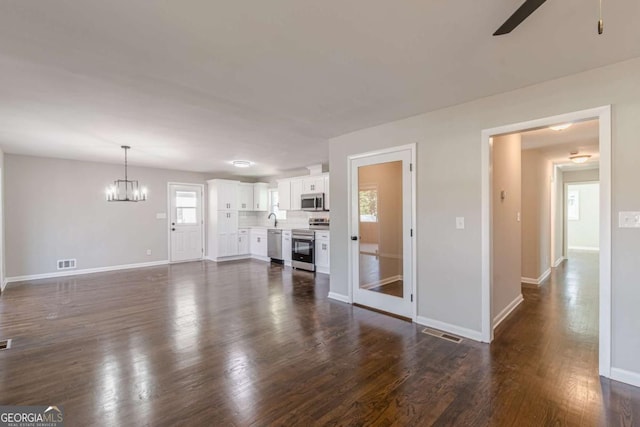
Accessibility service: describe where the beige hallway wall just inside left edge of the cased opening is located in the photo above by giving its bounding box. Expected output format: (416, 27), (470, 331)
(491, 134), (522, 324)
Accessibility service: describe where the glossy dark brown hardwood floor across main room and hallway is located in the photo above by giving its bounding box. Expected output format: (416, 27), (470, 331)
(0, 260), (640, 426)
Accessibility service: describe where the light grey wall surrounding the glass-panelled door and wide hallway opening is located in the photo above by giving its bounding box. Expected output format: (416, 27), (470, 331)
(329, 58), (640, 382)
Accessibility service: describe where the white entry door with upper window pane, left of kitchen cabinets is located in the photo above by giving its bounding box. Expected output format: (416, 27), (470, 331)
(169, 184), (204, 262)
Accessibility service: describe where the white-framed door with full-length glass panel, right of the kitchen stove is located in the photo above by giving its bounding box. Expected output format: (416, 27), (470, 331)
(351, 149), (413, 317)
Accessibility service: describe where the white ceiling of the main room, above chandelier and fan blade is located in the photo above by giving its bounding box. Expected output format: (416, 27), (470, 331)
(0, 0), (640, 176)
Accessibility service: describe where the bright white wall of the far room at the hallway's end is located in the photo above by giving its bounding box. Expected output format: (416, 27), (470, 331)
(567, 183), (600, 251)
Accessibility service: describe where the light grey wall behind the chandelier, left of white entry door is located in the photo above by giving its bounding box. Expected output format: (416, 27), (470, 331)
(5, 154), (205, 277)
